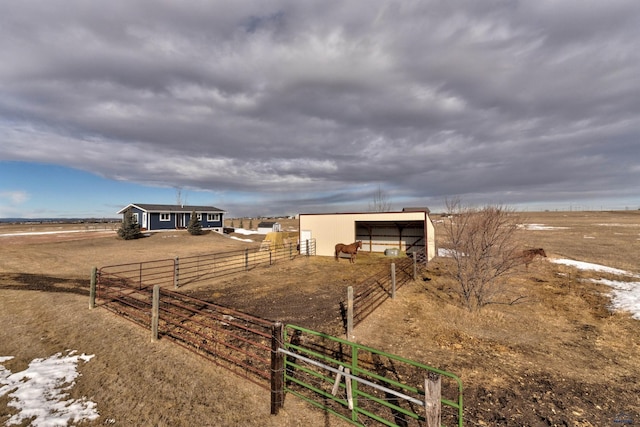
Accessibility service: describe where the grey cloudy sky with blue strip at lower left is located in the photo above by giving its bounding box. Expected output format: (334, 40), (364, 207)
(0, 0), (640, 217)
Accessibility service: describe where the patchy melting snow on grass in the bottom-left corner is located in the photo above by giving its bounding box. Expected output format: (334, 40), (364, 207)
(0, 351), (100, 427)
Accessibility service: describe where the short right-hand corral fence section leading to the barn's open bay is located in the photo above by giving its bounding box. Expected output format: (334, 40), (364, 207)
(340, 257), (419, 338)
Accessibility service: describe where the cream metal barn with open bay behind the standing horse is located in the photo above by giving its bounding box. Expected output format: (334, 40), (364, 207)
(299, 208), (436, 261)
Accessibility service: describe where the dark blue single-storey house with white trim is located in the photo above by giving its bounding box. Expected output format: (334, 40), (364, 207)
(118, 203), (226, 233)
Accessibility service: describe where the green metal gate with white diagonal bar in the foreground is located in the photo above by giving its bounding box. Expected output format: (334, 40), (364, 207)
(279, 325), (463, 426)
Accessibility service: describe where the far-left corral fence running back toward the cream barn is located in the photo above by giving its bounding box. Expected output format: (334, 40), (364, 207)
(98, 239), (316, 289)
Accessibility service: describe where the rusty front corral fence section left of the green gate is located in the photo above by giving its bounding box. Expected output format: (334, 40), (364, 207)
(90, 278), (274, 389)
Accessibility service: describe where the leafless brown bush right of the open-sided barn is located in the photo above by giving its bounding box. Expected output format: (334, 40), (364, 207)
(445, 200), (524, 311)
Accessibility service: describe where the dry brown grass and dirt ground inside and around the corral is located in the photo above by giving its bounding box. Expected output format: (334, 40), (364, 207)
(0, 211), (640, 426)
